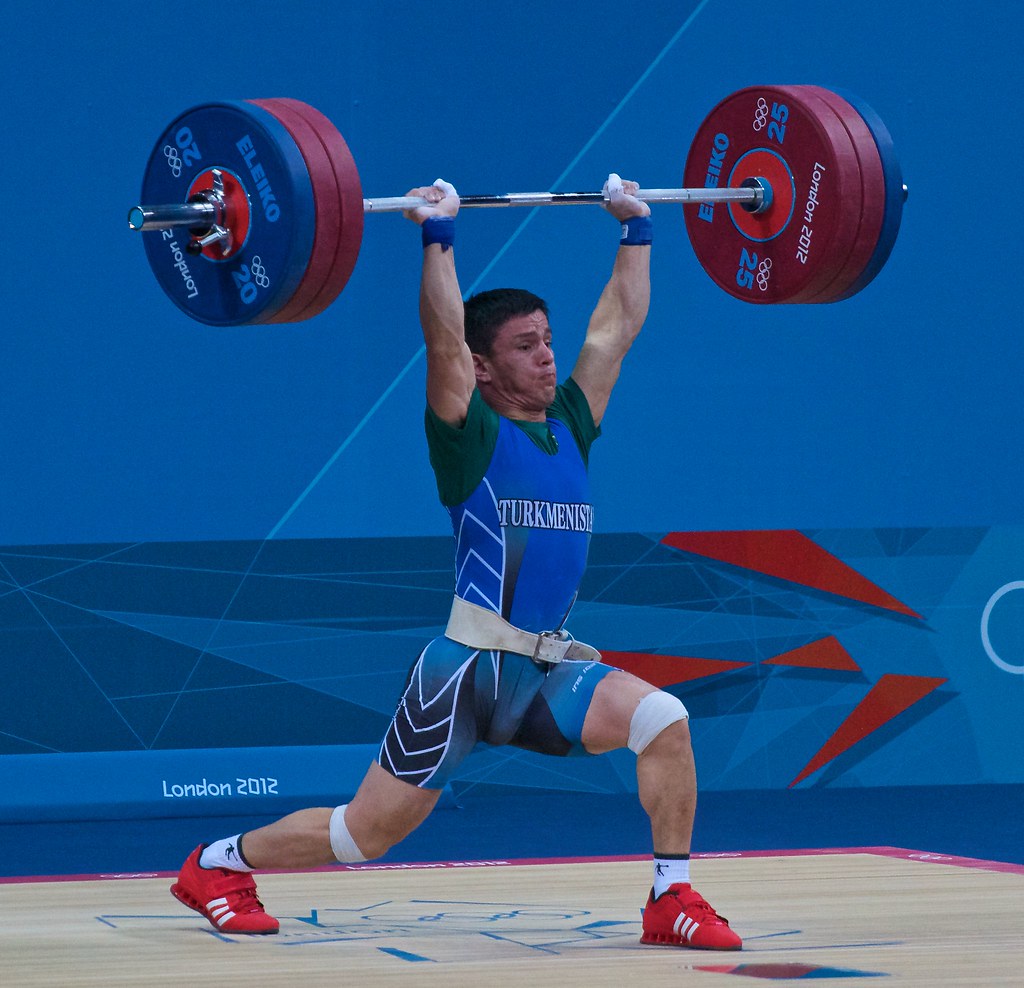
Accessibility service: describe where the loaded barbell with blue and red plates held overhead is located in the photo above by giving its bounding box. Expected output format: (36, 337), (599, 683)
(128, 86), (906, 326)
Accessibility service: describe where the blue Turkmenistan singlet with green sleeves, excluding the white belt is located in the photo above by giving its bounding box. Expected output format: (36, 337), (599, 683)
(379, 378), (610, 788)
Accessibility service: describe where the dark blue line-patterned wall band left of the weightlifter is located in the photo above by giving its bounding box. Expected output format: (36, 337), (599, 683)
(0, 540), (450, 754)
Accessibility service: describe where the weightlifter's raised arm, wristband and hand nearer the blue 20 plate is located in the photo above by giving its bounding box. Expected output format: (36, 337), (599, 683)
(406, 179), (476, 426)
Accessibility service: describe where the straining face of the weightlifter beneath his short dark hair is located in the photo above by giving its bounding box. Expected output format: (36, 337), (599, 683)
(474, 310), (557, 422)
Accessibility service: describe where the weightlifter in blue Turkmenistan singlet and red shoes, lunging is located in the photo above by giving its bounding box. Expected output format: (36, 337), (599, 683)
(171, 175), (742, 950)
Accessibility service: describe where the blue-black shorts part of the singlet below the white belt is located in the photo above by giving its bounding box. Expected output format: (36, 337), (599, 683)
(377, 637), (613, 789)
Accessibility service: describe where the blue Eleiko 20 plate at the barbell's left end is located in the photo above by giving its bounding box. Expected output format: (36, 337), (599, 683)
(141, 101), (316, 326)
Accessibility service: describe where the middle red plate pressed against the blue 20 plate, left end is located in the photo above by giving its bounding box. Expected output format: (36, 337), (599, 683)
(249, 99), (341, 323)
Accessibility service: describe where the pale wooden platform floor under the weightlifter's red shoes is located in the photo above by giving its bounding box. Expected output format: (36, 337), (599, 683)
(0, 848), (1024, 988)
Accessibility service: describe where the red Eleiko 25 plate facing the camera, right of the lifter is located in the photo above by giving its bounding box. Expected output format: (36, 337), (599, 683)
(683, 86), (861, 304)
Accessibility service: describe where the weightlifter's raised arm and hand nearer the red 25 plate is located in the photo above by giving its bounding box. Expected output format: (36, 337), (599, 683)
(572, 175), (650, 425)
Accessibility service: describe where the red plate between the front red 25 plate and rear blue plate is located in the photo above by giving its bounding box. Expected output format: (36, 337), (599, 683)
(801, 86), (886, 302)
